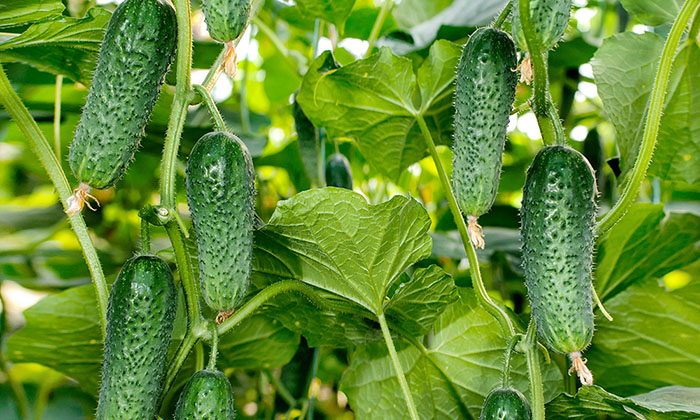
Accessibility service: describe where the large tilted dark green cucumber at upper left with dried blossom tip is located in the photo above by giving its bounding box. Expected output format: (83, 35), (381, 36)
(69, 0), (177, 189)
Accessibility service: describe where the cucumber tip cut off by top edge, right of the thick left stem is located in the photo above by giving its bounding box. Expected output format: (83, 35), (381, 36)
(202, 0), (250, 42)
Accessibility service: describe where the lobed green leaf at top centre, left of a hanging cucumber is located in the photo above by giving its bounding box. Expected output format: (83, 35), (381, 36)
(298, 41), (461, 179)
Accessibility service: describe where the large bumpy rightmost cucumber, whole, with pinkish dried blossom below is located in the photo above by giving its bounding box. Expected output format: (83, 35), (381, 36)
(520, 146), (597, 354)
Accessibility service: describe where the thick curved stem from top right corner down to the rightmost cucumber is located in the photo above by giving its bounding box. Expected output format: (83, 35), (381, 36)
(596, 0), (700, 236)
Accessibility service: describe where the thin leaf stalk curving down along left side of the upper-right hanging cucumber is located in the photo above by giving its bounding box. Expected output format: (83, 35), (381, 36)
(414, 113), (515, 336)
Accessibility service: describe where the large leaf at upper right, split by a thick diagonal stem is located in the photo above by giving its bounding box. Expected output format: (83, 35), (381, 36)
(592, 32), (700, 183)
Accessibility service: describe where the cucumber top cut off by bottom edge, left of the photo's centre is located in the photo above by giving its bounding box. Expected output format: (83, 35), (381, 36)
(175, 370), (234, 420)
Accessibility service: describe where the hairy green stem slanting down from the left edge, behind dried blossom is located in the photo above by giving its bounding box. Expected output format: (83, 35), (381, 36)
(0, 65), (109, 337)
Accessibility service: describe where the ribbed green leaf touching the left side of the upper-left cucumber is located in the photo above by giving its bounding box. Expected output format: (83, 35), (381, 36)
(0, 8), (111, 84)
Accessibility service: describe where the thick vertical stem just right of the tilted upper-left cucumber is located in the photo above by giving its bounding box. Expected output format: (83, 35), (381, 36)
(160, 0), (192, 210)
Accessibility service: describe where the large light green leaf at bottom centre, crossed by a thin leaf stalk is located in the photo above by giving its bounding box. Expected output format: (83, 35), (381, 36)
(341, 289), (561, 420)
